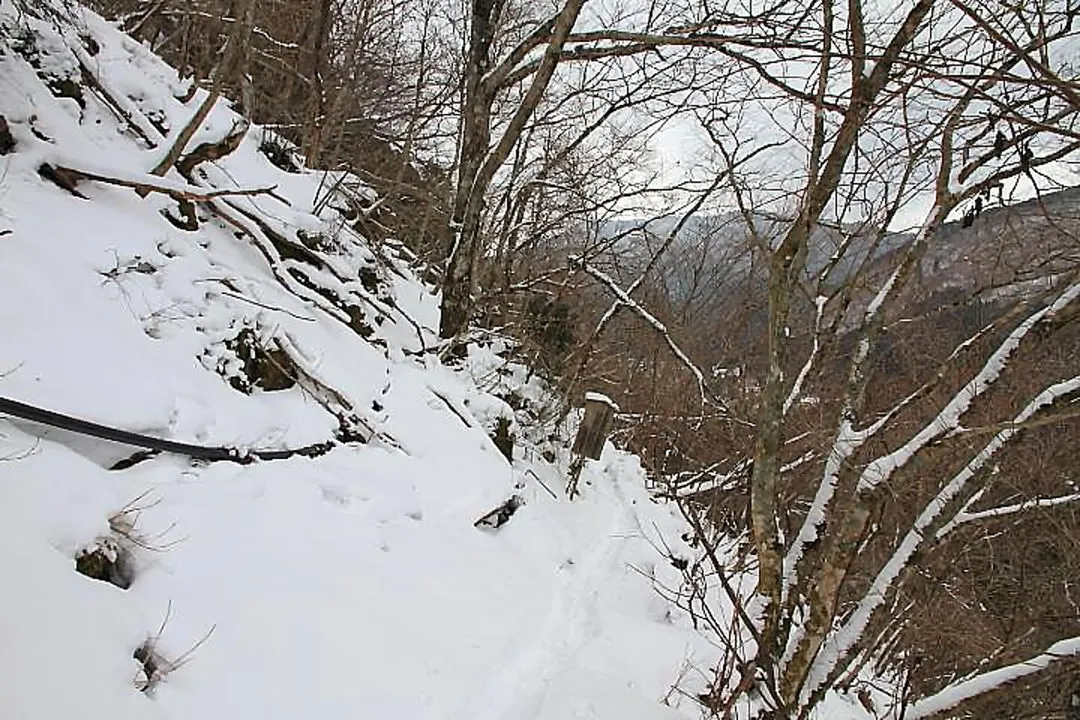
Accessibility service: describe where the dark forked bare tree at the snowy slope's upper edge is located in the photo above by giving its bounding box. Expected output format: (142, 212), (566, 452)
(429, 0), (725, 339)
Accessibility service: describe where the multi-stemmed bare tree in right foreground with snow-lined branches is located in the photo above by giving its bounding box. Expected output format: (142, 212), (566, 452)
(574, 0), (1080, 718)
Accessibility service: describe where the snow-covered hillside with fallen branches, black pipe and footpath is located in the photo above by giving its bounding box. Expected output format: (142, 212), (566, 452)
(0, 0), (710, 720)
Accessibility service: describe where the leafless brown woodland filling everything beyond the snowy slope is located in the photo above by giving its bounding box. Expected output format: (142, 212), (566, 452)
(52, 0), (1080, 720)
